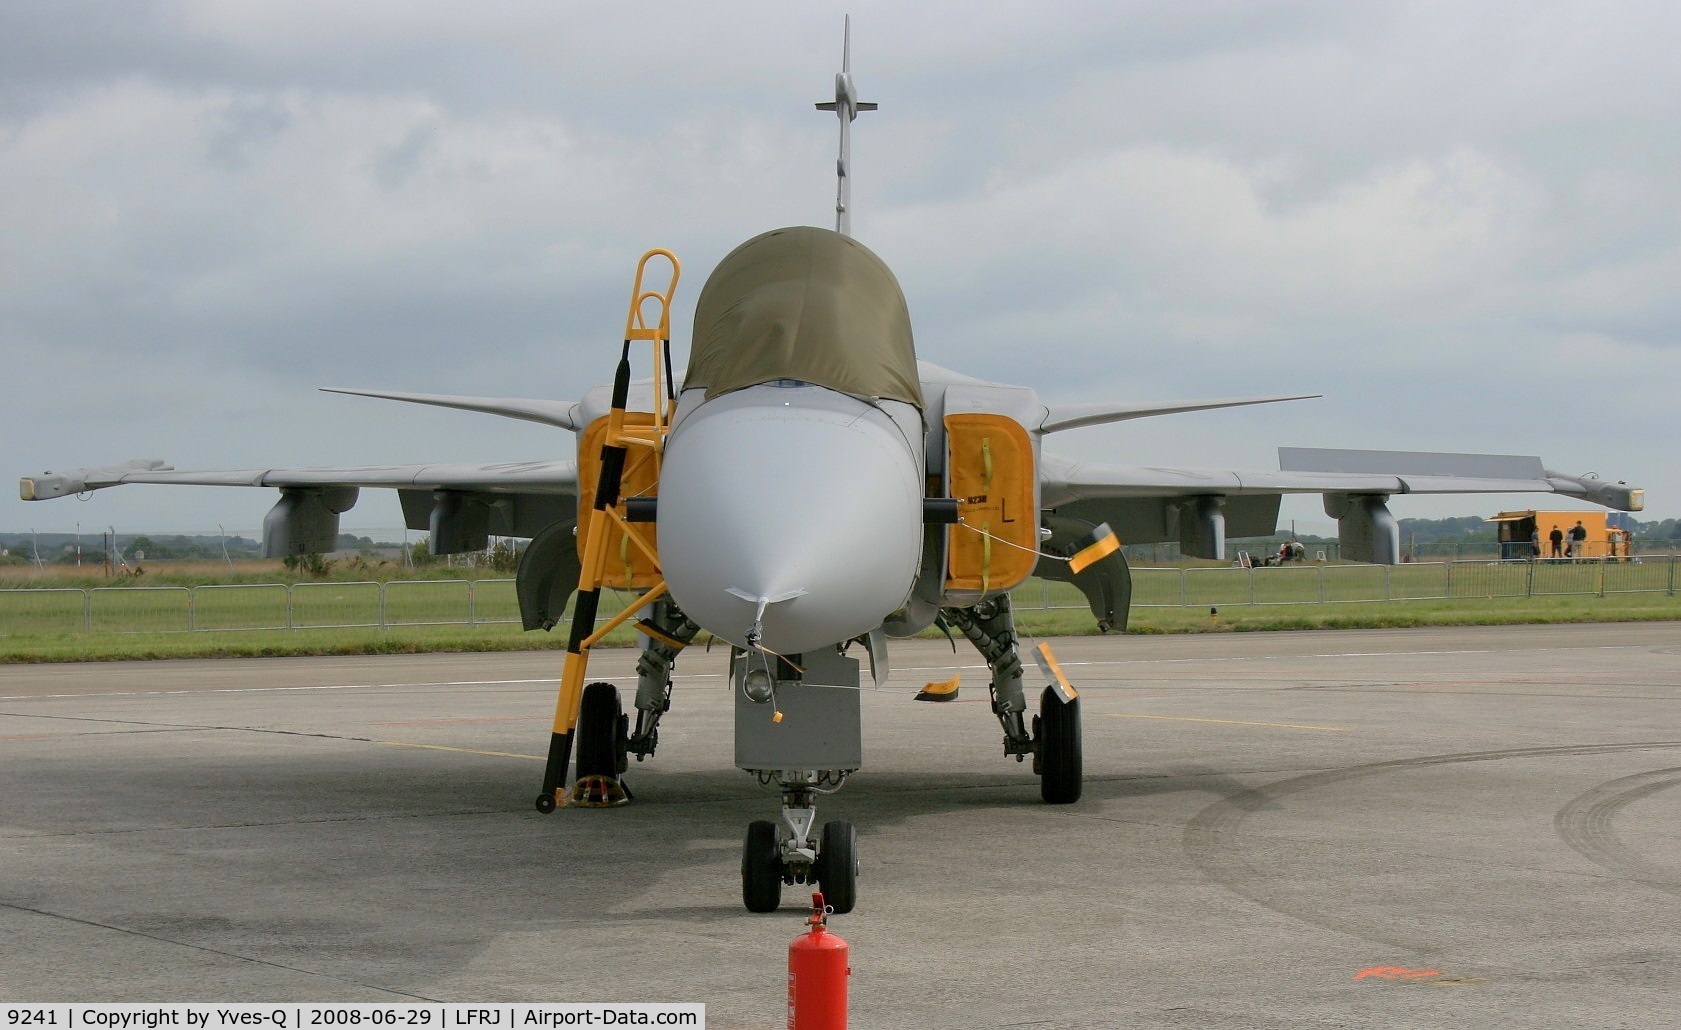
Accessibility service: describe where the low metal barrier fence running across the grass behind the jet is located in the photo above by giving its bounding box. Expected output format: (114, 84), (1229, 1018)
(0, 554), (1681, 638)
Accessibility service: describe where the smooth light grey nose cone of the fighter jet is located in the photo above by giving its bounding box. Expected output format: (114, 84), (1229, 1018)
(659, 390), (921, 655)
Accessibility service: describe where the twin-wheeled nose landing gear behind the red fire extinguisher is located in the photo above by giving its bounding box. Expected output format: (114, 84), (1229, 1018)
(741, 771), (857, 914)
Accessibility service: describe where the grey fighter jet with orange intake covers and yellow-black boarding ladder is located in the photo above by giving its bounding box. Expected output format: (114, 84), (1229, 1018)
(20, 24), (1642, 912)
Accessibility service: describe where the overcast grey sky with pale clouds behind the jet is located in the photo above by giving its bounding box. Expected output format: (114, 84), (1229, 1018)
(0, 0), (1681, 533)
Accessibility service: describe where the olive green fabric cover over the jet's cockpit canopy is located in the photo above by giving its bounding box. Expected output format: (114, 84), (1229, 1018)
(682, 227), (923, 408)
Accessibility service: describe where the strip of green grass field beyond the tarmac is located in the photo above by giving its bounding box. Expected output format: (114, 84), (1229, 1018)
(0, 566), (1681, 662)
